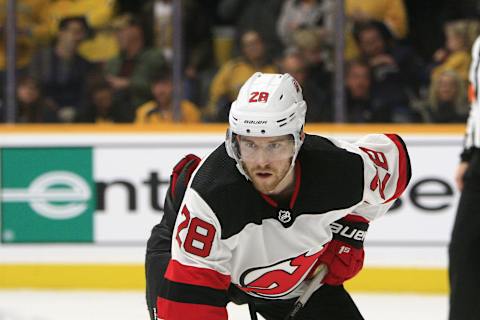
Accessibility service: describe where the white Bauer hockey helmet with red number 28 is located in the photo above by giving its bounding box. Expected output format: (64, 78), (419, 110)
(225, 72), (307, 178)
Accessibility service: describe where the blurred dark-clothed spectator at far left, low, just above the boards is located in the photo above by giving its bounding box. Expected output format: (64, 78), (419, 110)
(16, 77), (58, 123)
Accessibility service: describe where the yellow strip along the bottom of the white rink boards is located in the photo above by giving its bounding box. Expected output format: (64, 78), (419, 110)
(0, 264), (448, 294)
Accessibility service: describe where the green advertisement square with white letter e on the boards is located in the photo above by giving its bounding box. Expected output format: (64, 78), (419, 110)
(0, 148), (95, 243)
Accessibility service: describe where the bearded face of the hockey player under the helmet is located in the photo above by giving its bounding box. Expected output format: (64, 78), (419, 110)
(237, 135), (295, 194)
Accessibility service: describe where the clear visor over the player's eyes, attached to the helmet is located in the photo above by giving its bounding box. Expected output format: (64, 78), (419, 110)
(234, 135), (295, 161)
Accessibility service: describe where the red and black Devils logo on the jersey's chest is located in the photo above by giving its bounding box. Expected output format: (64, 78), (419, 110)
(240, 250), (323, 298)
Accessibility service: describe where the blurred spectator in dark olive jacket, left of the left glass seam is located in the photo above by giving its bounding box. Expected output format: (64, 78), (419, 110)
(104, 15), (166, 120)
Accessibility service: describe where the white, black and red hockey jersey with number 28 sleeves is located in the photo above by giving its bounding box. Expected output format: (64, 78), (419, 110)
(157, 134), (411, 320)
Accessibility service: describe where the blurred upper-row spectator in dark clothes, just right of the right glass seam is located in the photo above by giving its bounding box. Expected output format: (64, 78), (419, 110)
(354, 21), (419, 122)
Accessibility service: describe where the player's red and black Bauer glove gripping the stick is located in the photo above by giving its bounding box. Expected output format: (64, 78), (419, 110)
(319, 215), (368, 286)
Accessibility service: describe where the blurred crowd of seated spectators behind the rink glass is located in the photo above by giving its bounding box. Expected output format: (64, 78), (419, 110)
(0, 0), (480, 124)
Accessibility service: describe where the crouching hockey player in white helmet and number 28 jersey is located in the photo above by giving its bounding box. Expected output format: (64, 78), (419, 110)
(146, 73), (410, 320)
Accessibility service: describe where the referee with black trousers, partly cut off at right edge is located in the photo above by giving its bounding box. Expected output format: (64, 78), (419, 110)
(449, 36), (480, 320)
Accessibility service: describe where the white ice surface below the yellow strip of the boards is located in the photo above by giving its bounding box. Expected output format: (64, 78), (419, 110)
(0, 290), (448, 320)
